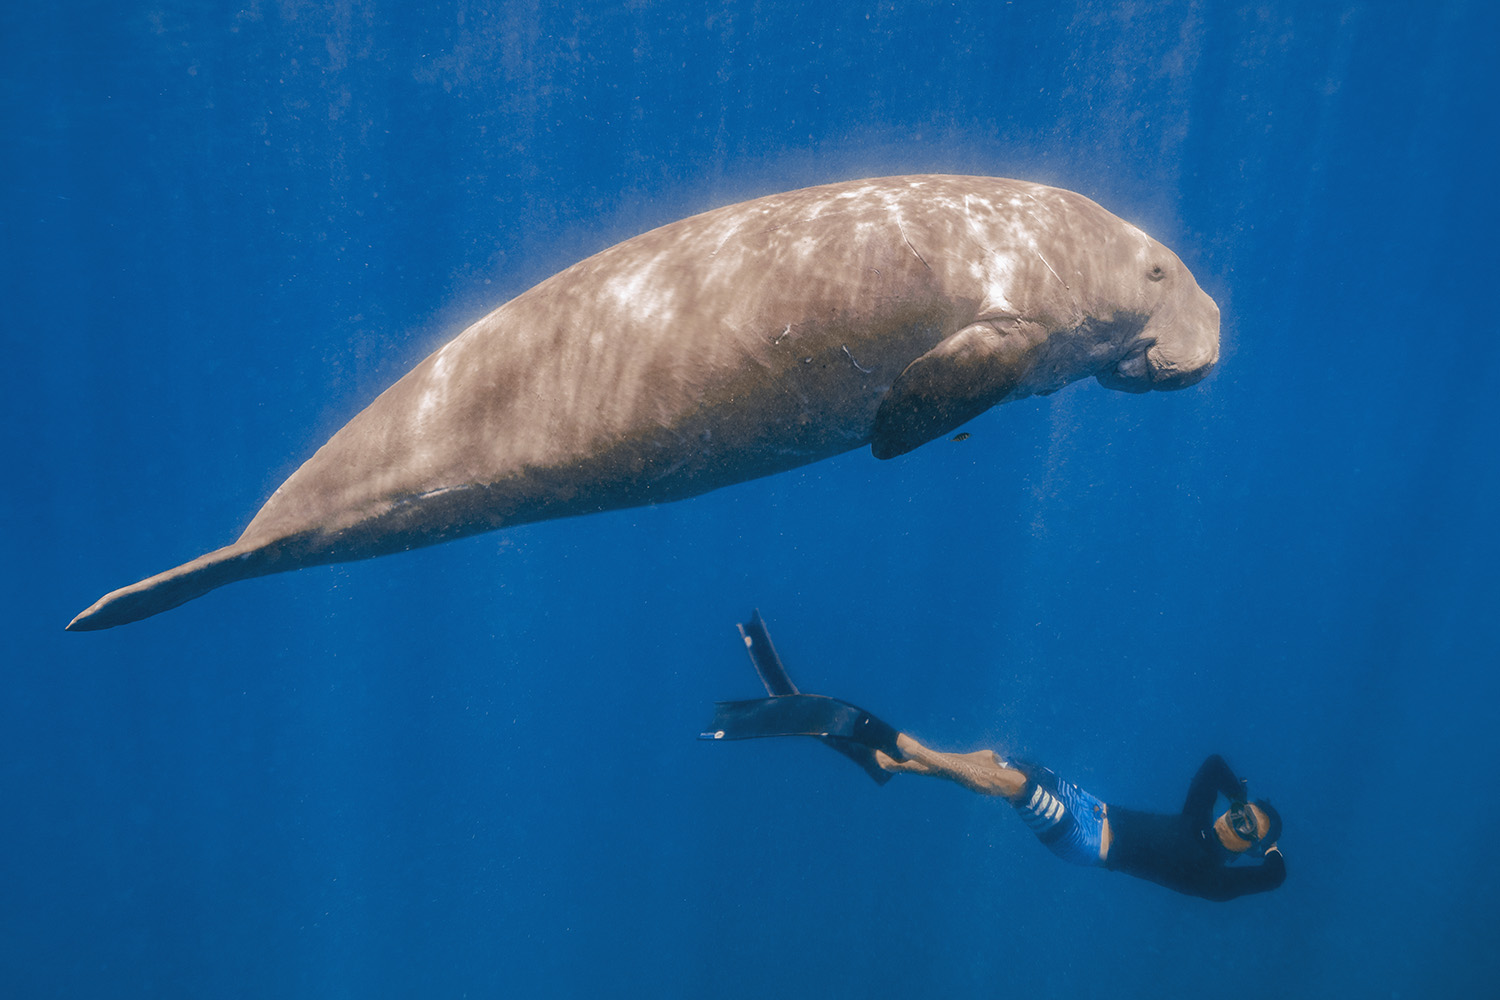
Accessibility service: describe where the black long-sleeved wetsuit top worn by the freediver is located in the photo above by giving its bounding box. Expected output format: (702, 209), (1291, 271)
(1104, 754), (1287, 901)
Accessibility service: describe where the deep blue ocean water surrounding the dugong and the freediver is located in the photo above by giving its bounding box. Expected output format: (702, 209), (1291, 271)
(0, 0), (1500, 1000)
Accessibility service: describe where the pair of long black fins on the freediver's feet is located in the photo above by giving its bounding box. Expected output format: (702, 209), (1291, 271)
(699, 610), (906, 784)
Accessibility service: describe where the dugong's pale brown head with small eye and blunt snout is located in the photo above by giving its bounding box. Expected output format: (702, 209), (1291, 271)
(1095, 232), (1220, 393)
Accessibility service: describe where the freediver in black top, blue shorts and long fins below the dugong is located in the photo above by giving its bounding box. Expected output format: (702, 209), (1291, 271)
(702, 612), (1287, 901)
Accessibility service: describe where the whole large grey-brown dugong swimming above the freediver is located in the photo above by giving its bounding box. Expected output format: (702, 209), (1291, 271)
(68, 175), (1220, 630)
